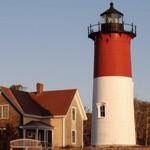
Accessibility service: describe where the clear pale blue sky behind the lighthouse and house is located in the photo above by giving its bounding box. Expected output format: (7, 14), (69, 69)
(0, 0), (150, 109)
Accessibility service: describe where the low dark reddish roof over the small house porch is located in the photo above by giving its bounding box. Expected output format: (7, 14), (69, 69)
(20, 121), (53, 130)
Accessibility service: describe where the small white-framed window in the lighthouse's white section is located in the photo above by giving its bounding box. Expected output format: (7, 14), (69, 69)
(96, 103), (106, 118)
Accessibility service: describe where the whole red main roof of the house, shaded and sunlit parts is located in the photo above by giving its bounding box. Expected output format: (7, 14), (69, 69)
(1, 87), (76, 116)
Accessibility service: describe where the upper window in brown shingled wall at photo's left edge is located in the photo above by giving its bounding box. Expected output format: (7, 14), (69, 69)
(0, 104), (9, 119)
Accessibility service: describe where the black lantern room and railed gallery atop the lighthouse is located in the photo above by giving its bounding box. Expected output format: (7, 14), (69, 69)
(88, 2), (136, 40)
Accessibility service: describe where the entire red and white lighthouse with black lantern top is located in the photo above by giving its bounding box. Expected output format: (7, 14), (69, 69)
(88, 2), (136, 146)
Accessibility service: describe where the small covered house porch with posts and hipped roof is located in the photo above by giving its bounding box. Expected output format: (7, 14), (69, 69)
(20, 121), (53, 147)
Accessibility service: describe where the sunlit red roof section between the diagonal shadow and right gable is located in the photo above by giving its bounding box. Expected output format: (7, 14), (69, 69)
(30, 89), (76, 115)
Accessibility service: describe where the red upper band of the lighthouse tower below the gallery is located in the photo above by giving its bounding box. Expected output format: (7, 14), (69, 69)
(94, 33), (132, 78)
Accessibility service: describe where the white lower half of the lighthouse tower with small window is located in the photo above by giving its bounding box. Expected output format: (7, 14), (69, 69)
(92, 76), (136, 146)
